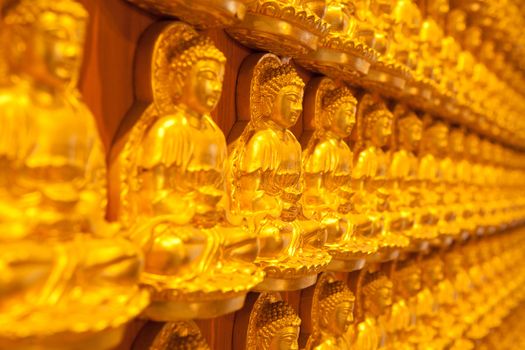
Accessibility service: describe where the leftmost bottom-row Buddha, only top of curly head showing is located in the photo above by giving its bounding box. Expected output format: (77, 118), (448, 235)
(144, 321), (210, 350)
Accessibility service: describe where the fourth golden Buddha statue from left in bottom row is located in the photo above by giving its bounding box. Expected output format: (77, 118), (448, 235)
(347, 270), (393, 350)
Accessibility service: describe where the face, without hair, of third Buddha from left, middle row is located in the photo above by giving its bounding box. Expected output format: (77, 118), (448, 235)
(270, 86), (303, 129)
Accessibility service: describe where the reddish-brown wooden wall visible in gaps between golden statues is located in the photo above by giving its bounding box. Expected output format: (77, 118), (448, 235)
(75, 0), (318, 350)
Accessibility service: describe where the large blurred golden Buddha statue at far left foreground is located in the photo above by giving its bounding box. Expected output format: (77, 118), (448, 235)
(0, 0), (149, 349)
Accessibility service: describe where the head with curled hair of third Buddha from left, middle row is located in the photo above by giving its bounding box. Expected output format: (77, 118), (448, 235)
(259, 64), (304, 129)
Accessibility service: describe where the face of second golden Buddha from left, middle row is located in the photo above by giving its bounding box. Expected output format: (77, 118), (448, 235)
(180, 59), (224, 114)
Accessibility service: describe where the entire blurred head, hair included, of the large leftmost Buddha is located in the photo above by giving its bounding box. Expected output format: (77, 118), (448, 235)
(1, 0), (88, 90)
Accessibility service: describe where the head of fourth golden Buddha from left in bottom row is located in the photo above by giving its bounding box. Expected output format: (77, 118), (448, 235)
(362, 272), (393, 317)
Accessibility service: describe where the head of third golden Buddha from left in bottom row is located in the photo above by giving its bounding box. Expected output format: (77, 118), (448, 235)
(317, 281), (355, 336)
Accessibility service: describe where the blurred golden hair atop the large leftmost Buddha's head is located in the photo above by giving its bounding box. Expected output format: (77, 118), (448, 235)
(0, 0), (88, 25)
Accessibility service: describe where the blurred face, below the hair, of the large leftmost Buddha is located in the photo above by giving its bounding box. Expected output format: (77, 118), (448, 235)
(19, 11), (86, 88)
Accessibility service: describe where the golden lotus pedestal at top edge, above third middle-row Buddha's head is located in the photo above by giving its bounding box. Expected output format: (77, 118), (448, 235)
(227, 0), (329, 57)
